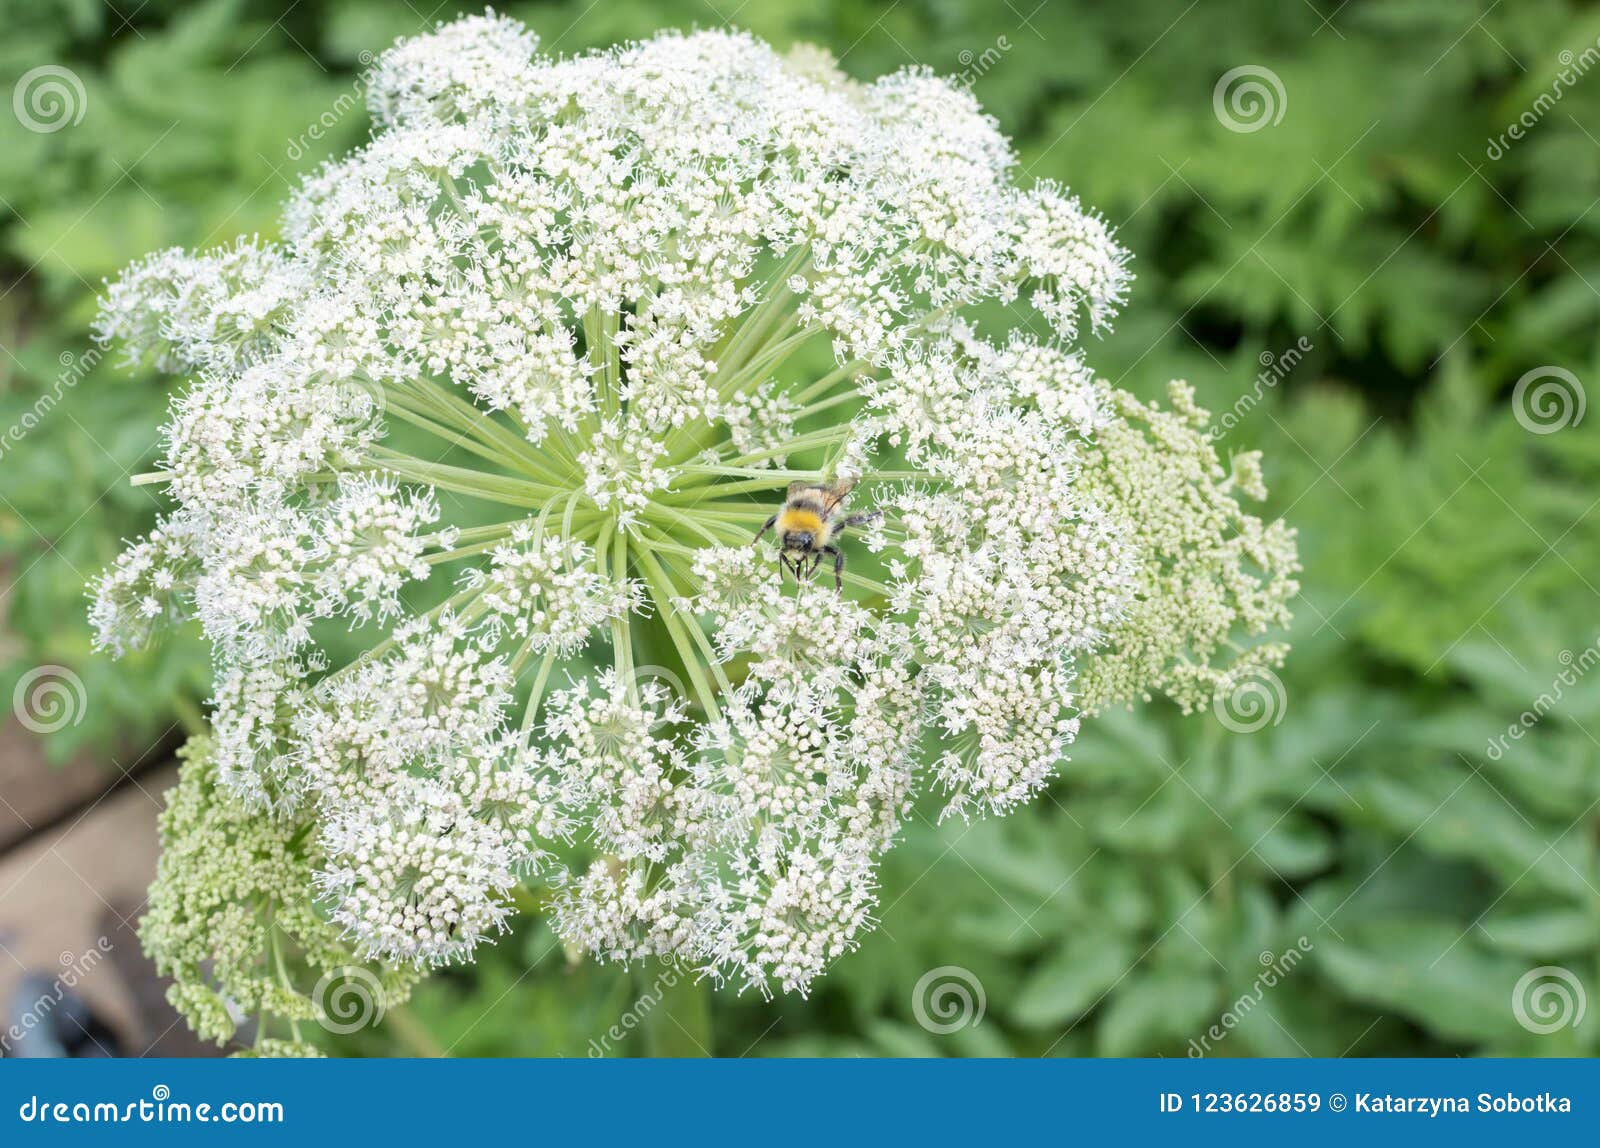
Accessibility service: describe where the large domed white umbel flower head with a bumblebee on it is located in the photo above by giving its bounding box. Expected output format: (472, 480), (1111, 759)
(93, 14), (1296, 1036)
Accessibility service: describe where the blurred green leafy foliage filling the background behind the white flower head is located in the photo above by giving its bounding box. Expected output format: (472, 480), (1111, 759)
(0, 0), (1600, 1055)
